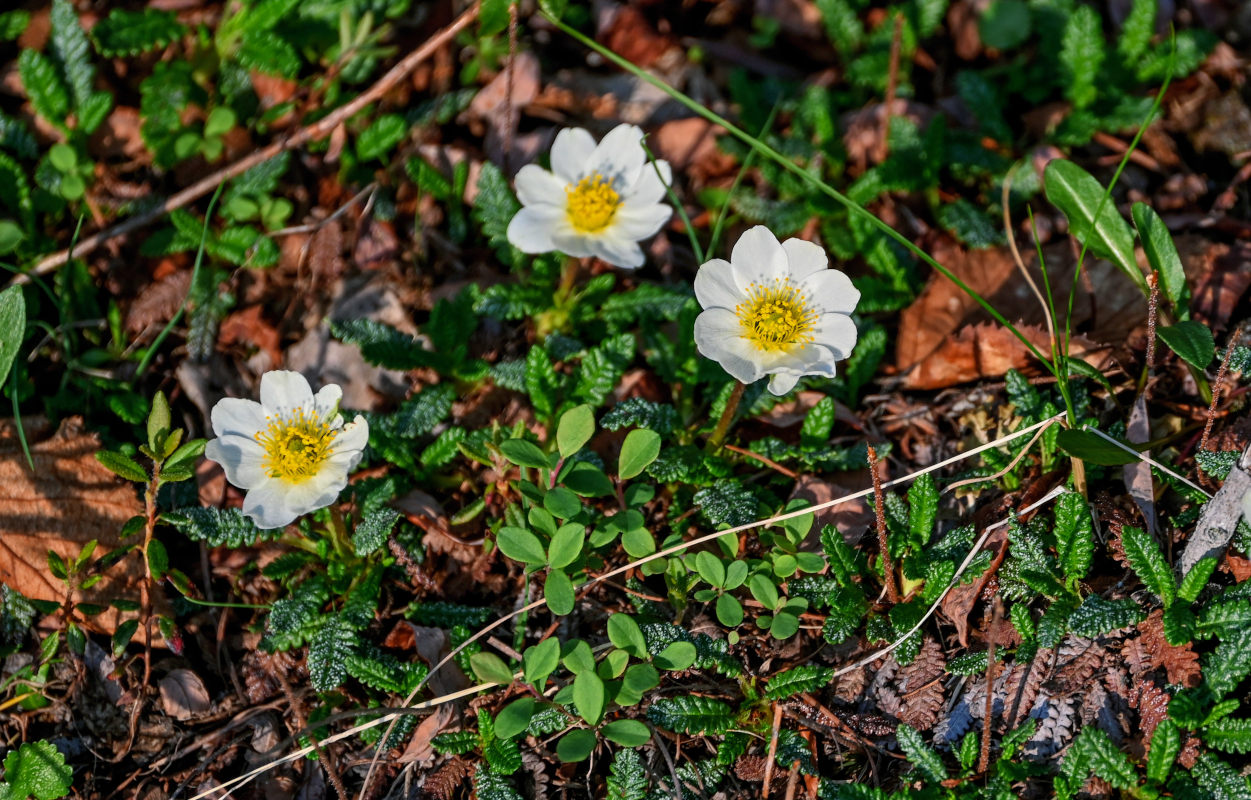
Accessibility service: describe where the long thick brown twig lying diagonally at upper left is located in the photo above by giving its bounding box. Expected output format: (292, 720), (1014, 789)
(11, 3), (478, 284)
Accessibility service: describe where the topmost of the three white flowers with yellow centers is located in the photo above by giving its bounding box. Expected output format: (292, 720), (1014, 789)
(508, 125), (673, 268)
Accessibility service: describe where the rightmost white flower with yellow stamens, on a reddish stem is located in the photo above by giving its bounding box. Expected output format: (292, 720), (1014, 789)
(696, 225), (859, 394)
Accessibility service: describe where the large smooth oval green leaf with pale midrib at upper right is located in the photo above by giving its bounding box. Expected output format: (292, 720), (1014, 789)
(1043, 157), (1147, 294)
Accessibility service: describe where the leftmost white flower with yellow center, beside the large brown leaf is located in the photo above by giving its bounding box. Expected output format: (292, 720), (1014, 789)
(204, 369), (369, 528)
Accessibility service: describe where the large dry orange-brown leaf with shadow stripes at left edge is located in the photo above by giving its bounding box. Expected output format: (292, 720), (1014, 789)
(0, 417), (143, 633)
